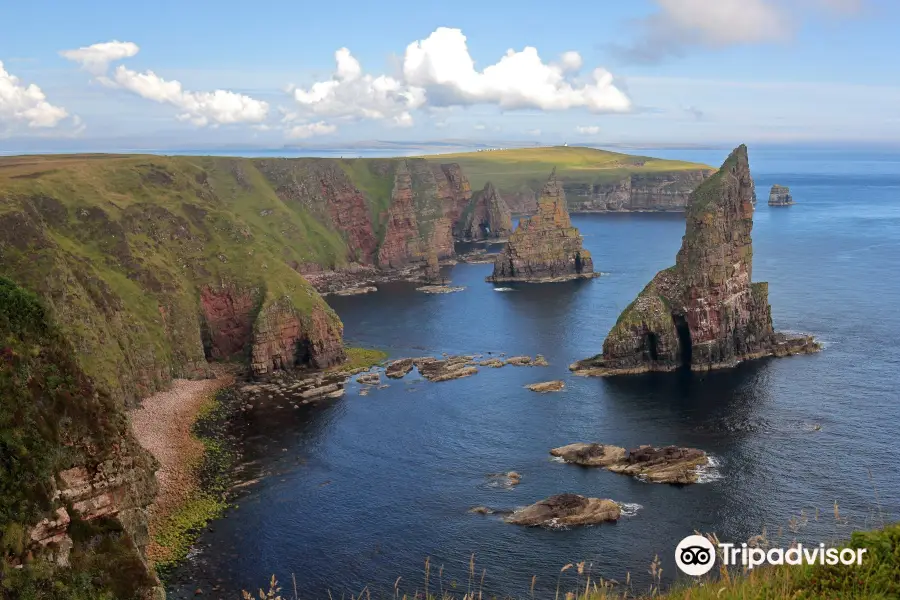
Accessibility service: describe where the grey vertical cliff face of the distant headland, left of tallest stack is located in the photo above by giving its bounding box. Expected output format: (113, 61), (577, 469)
(566, 171), (710, 212)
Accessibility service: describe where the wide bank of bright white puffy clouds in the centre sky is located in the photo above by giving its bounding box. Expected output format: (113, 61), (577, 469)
(289, 27), (631, 126)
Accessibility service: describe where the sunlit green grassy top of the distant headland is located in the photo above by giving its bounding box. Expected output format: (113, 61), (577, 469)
(425, 146), (714, 199)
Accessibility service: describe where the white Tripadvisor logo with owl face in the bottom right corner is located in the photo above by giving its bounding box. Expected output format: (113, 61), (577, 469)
(675, 535), (868, 577)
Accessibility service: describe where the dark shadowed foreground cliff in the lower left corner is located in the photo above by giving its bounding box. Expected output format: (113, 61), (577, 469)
(0, 278), (159, 599)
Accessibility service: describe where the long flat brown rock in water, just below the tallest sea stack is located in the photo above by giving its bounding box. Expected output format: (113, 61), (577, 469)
(550, 443), (709, 484)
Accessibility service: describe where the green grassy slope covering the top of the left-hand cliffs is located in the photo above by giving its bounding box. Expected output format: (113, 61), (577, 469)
(0, 155), (347, 408)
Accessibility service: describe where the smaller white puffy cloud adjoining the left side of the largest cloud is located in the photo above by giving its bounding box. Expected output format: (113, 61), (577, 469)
(293, 48), (425, 127)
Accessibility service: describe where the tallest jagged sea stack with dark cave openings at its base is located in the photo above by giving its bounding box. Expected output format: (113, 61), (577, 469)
(570, 145), (821, 375)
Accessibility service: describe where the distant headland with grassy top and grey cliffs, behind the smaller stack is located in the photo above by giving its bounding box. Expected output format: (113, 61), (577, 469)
(430, 146), (715, 214)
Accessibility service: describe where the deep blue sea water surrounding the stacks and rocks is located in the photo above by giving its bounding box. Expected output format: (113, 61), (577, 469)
(169, 147), (900, 598)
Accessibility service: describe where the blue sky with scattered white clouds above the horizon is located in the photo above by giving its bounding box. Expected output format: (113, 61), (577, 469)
(0, 0), (900, 151)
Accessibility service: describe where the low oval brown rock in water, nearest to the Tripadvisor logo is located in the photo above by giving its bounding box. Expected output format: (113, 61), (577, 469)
(504, 494), (622, 527)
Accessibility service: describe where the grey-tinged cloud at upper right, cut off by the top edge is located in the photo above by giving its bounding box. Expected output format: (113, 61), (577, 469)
(620, 0), (865, 62)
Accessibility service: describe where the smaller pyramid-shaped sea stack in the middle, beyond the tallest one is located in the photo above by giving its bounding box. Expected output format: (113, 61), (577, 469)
(487, 169), (597, 283)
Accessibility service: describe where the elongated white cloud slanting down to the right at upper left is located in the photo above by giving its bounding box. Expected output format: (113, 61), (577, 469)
(60, 41), (269, 127)
